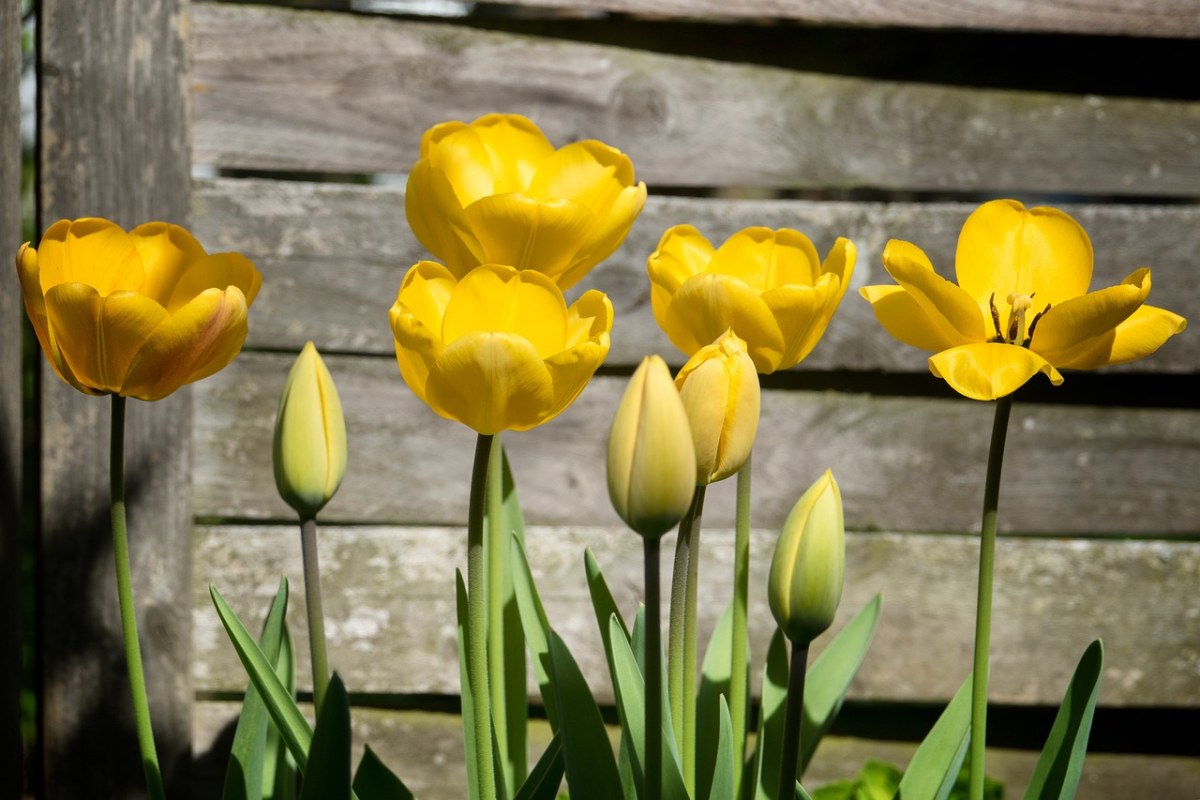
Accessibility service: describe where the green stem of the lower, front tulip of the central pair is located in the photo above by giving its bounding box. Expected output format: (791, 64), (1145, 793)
(467, 433), (499, 800)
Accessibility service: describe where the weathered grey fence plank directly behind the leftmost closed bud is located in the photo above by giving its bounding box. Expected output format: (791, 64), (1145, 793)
(193, 353), (1200, 536)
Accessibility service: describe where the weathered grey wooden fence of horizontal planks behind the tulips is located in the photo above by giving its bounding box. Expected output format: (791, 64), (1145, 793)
(9, 0), (1200, 799)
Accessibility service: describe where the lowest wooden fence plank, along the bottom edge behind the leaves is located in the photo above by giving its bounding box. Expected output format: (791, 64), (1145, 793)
(193, 703), (1200, 800)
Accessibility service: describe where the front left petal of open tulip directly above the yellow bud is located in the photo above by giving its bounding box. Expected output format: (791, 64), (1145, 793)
(662, 272), (784, 373)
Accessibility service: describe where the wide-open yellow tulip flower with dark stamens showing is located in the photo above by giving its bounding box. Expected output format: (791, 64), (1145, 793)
(862, 200), (1187, 401)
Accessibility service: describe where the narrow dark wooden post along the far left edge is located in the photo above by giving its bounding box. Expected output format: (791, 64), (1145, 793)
(0, 2), (24, 800)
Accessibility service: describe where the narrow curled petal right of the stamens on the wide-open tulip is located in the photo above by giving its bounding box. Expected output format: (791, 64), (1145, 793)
(1031, 269), (1150, 366)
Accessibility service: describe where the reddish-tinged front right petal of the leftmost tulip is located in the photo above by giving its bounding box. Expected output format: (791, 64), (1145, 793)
(121, 285), (246, 401)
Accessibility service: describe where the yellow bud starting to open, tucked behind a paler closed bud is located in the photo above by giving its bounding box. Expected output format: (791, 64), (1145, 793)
(676, 331), (760, 486)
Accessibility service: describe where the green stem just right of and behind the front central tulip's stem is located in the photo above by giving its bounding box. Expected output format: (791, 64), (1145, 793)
(484, 433), (508, 790)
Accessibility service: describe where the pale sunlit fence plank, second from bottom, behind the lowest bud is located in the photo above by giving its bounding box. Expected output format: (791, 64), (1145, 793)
(192, 525), (1200, 708)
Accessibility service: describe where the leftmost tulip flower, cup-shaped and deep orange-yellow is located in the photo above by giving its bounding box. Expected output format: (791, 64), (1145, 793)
(17, 218), (263, 401)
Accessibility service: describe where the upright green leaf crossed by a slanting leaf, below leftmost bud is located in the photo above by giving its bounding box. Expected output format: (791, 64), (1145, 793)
(221, 578), (288, 800)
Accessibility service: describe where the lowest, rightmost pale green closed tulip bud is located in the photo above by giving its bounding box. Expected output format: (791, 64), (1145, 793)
(767, 470), (846, 645)
